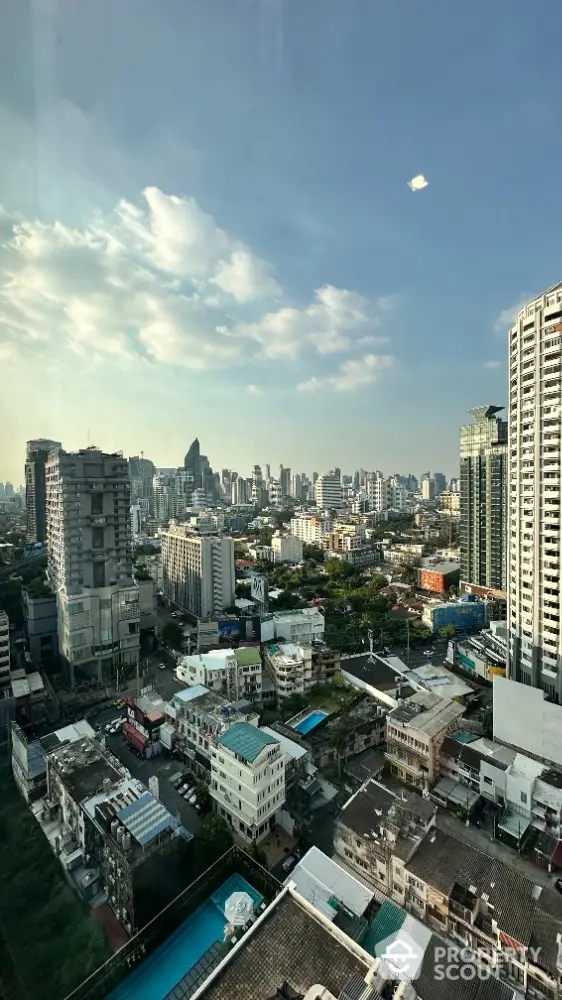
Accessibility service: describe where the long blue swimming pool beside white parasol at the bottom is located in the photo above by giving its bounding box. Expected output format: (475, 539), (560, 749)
(109, 875), (263, 1000)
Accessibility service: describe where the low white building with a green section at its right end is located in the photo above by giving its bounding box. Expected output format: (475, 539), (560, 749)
(176, 647), (262, 701)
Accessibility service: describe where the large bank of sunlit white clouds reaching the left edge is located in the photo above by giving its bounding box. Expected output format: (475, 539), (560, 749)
(0, 187), (392, 382)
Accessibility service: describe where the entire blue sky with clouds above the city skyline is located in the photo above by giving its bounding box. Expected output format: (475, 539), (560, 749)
(0, 0), (562, 483)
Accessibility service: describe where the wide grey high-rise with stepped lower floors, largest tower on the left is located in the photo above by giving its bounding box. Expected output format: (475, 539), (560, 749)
(45, 448), (140, 681)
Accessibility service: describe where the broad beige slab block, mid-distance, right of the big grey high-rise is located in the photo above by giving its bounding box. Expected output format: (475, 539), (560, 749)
(162, 525), (236, 618)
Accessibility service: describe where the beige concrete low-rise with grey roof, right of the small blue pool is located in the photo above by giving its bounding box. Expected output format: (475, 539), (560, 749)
(385, 691), (464, 791)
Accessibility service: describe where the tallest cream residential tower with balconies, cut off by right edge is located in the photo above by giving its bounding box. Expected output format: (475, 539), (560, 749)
(508, 282), (562, 703)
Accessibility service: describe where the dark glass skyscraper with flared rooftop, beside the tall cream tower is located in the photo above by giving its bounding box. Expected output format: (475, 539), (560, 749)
(459, 406), (507, 590)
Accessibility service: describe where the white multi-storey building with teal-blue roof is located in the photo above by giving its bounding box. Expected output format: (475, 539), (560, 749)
(210, 722), (285, 842)
